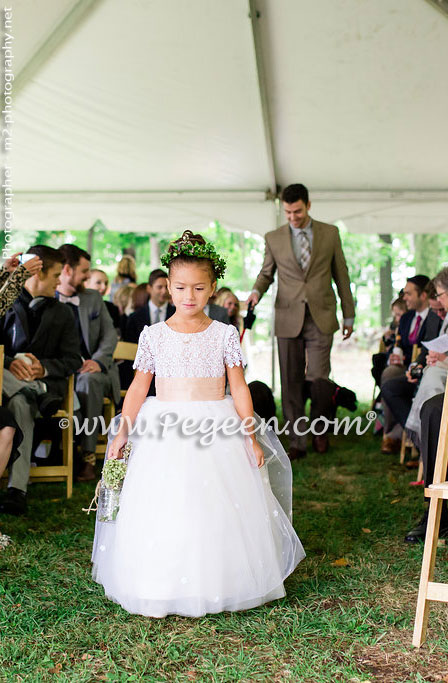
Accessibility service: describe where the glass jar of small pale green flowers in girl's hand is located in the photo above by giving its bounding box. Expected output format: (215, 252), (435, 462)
(82, 441), (132, 522)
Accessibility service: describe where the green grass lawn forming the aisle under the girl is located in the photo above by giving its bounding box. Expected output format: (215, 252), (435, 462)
(0, 408), (448, 683)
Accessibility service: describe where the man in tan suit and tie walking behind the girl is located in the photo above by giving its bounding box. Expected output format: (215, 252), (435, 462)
(247, 184), (355, 460)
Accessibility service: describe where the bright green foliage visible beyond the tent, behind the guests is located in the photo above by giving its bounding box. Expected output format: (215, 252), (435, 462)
(4, 226), (448, 338)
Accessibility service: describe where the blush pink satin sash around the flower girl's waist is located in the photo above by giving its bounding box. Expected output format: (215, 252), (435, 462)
(156, 375), (226, 401)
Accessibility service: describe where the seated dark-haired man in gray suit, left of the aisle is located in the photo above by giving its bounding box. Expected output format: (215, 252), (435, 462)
(56, 244), (120, 481)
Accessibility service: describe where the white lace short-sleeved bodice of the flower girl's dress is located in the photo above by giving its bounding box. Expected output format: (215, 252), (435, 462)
(134, 320), (245, 377)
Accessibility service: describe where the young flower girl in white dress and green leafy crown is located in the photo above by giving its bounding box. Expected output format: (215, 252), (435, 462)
(92, 231), (305, 617)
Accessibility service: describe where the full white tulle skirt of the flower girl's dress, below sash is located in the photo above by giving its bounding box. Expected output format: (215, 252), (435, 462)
(92, 397), (305, 617)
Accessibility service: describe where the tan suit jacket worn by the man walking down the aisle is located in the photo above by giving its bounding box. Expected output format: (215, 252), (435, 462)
(254, 220), (355, 337)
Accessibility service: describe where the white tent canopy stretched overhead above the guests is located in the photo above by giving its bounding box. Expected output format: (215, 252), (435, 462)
(8, 0), (448, 234)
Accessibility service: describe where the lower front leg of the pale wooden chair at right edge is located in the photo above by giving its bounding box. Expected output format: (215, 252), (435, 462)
(412, 498), (443, 647)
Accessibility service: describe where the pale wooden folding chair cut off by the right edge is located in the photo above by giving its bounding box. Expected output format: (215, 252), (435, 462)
(412, 381), (448, 647)
